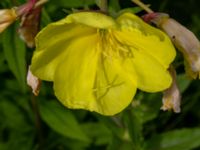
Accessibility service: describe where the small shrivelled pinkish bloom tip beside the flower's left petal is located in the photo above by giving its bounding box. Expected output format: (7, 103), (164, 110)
(27, 67), (41, 96)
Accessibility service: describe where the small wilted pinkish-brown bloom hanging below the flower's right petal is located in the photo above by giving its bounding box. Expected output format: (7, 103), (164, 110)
(161, 66), (181, 113)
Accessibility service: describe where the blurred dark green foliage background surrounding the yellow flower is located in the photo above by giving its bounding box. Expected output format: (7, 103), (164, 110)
(0, 0), (200, 150)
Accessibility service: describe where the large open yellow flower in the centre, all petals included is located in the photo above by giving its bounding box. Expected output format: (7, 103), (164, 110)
(31, 12), (175, 115)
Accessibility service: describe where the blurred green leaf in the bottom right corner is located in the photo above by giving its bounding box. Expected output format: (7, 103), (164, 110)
(145, 128), (200, 150)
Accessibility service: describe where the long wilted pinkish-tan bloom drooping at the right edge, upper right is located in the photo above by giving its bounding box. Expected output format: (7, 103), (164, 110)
(147, 13), (200, 79)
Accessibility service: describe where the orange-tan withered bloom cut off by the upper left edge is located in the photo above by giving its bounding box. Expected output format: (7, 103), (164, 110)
(0, 8), (17, 33)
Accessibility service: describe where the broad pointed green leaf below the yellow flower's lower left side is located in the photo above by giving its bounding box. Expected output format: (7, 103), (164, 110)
(40, 100), (89, 141)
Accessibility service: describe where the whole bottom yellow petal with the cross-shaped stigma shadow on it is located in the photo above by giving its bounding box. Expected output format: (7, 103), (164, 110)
(54, 35), (136, 115)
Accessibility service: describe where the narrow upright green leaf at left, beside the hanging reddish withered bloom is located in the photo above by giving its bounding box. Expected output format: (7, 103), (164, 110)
(3, 26), (26, 91)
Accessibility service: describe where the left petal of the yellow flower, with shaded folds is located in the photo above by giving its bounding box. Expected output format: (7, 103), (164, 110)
(31, 21), (96, 81)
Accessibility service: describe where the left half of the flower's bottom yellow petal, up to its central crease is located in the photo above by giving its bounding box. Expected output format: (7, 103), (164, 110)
(54, 35), (99, 110)
